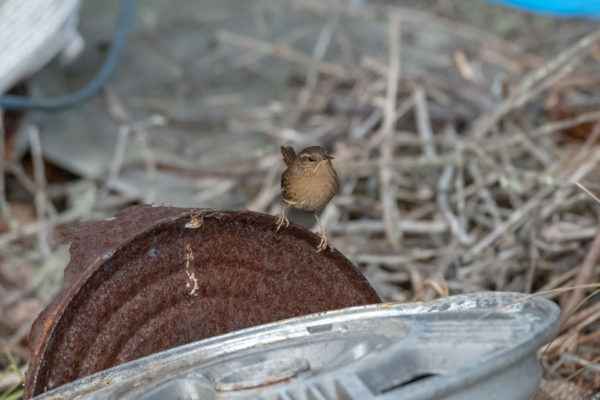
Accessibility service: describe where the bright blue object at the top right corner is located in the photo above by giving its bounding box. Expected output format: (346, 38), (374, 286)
(487, 0), (600, 18)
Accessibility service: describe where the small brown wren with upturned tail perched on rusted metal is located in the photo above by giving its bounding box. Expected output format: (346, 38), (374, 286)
(277, 146), (338, 251)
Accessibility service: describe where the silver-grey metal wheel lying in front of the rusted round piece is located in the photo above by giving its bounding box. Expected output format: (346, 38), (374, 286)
(31, 293), (559, 400)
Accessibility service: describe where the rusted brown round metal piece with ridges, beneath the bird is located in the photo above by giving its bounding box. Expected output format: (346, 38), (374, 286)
(25, 206), (380, 398)
